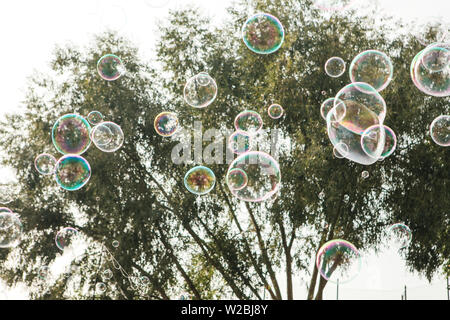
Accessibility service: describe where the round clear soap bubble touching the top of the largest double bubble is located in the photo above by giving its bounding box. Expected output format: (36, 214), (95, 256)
(350, 50), (394, 92)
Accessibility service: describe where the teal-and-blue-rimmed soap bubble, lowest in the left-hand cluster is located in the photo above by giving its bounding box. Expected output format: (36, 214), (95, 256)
(55, 154), (91, 191)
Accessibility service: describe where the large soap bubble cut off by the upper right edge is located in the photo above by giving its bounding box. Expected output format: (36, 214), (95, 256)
(410, 44), (450, 97)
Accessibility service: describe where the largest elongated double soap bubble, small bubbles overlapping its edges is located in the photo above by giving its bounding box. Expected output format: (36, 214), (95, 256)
(327, 82), (386, 165)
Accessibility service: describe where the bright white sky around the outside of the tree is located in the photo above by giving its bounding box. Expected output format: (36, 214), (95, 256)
(0, 0), (450, 299)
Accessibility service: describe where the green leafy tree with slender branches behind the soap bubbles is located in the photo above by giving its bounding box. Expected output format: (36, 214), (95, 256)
(0, 0), (450, 299)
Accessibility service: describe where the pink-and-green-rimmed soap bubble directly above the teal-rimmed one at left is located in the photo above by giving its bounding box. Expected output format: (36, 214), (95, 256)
(52, 114), (91, 154)
